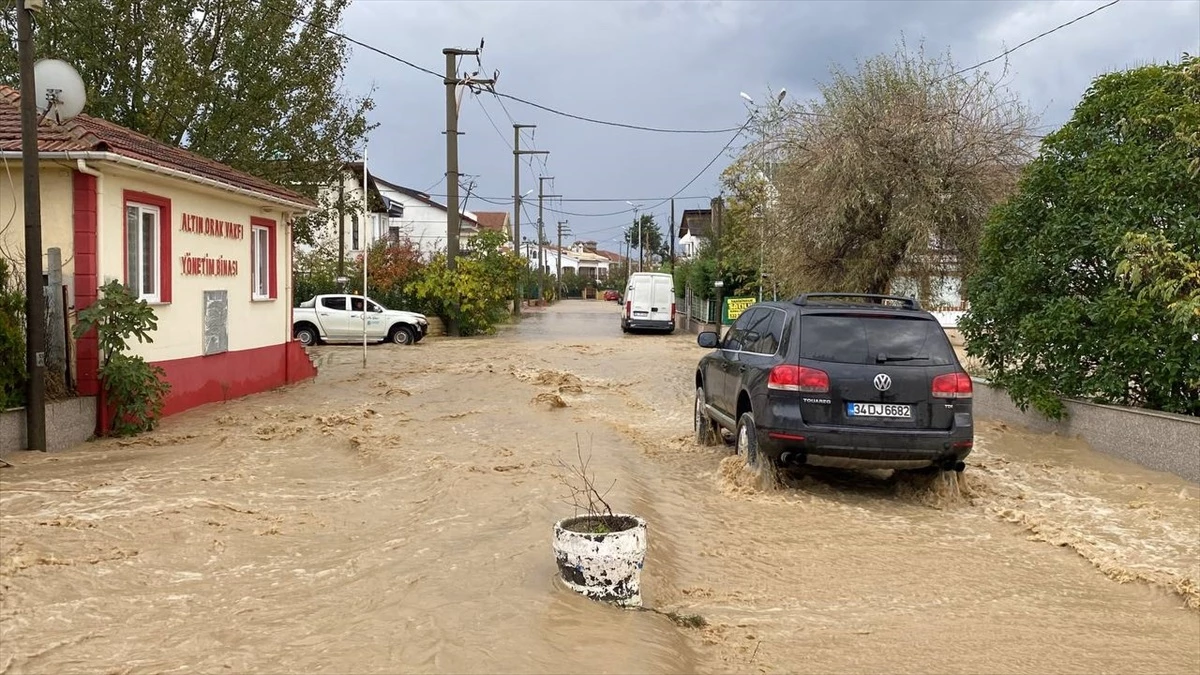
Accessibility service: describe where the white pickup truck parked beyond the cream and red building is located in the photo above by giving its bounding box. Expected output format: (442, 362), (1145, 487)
(292, 294), (430, 347)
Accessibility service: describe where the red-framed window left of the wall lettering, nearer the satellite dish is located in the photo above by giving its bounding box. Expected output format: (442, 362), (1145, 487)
(125, 191), (170, 304)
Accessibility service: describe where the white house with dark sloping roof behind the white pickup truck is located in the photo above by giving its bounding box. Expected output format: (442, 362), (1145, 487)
(318, 162), (480, 256)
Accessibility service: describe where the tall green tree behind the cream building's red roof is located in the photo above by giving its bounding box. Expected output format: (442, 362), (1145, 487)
(0, 0), (372, 238)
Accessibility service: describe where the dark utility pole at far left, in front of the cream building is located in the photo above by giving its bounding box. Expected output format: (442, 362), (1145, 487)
(17, 1), (46, 453)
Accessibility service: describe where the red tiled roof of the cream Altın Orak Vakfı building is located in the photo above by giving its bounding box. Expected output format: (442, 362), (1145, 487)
(0, 85), (317, 207)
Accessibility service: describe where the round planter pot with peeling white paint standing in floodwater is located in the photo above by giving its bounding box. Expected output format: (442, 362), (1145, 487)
(554, 514), (646, 607)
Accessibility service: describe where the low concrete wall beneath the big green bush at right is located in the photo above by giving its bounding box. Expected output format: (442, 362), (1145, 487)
(972, 377), (1200, 483)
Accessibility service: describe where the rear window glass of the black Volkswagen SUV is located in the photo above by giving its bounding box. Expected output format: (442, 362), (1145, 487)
(800, 315), (955, 365)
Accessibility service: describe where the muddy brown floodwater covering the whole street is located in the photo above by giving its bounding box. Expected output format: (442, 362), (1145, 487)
(0, 301), (1200, 674)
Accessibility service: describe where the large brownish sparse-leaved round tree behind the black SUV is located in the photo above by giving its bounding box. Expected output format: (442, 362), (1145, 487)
(763, 38), (1034, 293)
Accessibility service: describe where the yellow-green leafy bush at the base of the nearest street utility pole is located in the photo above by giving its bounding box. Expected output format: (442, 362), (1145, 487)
(406, 232), (528, 335)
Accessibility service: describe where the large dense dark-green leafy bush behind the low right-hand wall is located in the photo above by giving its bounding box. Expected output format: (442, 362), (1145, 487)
(959, 56), (1200, 418)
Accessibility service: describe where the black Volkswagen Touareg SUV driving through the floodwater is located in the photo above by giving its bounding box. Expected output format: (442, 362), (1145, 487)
(695, 293), (974, 471)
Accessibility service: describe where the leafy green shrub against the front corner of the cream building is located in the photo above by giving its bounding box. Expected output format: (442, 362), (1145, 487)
(74, 281), (170, 436)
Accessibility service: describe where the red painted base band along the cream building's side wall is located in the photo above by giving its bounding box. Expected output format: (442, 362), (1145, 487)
(155, 341), (317, 416)
